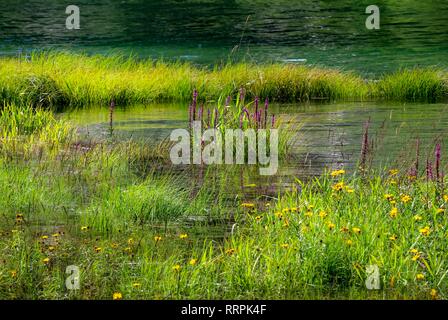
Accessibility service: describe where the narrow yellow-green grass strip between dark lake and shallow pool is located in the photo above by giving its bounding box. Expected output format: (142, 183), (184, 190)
(0, 53), (448, 108)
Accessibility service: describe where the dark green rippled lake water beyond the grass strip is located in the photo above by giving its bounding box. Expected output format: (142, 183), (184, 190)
(0, 0), (448, 75)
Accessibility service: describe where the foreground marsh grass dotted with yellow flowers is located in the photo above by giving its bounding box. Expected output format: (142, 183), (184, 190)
(0, 106), (448, 299)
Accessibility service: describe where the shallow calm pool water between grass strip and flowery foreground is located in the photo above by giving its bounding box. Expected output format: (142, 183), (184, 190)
(64, 102), (448, 190)
